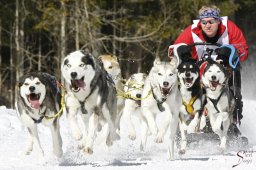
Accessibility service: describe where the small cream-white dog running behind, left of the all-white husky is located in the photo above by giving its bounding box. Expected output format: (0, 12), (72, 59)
(123, 73), (146, 140)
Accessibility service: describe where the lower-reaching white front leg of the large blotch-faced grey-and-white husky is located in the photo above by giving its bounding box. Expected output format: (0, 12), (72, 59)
(84, 113), (99, 154)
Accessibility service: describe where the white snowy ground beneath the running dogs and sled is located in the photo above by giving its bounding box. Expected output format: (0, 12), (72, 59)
(0, 100), (256, 170)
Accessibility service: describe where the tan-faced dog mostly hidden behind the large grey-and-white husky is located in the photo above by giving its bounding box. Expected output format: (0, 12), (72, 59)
(98, 55), (124, 118)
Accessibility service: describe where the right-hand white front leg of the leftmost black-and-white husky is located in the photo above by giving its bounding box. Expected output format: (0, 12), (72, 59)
(50, 119), (63, 158)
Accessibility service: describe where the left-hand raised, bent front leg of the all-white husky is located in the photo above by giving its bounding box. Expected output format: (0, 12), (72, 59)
(142, 107), (158, 136)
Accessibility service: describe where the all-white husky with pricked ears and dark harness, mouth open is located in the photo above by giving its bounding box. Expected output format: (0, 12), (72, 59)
(141, 58), (181, 159)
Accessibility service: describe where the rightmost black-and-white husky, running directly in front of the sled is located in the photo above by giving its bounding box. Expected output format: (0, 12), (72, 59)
(200, 60), (235, 151)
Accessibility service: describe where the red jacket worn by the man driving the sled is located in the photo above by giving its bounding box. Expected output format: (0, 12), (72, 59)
(174, 20), (248, 61)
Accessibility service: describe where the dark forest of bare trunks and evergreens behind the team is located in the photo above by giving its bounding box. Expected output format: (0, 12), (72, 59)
(0, 0), (256, 108)
